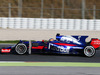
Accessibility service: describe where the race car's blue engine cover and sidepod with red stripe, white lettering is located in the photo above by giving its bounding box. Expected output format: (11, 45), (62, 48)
(45, 36), (88, 54)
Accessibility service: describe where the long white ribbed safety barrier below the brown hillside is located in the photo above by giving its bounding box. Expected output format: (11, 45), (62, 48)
(0, 17), (100, 30)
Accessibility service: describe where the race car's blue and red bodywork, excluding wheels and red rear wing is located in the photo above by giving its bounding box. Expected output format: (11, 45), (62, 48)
(0, 35), (88, 54)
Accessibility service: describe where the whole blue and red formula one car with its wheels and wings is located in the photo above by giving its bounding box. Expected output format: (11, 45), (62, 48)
(1, 34), (100, 57)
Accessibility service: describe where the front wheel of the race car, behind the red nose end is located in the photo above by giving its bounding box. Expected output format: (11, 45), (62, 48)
(15, 43), (27, 55)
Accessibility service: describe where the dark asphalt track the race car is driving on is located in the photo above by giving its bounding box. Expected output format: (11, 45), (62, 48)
(0, 44), (100, 63)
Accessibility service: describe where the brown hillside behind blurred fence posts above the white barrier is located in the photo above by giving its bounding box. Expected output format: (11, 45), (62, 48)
(0, 0), (100, 19)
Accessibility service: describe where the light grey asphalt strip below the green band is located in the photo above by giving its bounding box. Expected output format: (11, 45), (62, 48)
(0, 67), (100, 75)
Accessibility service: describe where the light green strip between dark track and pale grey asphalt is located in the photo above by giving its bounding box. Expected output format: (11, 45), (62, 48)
(0, 62), (100, 67)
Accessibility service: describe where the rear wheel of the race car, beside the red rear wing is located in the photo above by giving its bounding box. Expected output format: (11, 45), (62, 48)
(84, 46), (96, 57)
